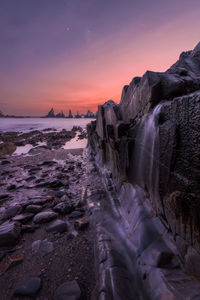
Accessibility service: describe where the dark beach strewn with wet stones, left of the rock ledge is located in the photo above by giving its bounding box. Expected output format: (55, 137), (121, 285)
(0, 130), (95, 300)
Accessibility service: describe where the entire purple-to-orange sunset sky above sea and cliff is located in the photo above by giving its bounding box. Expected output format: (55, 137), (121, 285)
(0, 0), (200, 116)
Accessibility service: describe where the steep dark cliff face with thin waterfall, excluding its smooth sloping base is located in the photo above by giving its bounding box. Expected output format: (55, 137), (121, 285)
(87, 43), (200, 276)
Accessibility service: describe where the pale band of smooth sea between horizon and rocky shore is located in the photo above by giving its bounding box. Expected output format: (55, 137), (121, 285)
(0, 118), (94, 132)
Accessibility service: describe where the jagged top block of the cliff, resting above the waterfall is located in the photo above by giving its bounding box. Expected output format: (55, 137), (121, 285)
(120, 44), (200, 121)
